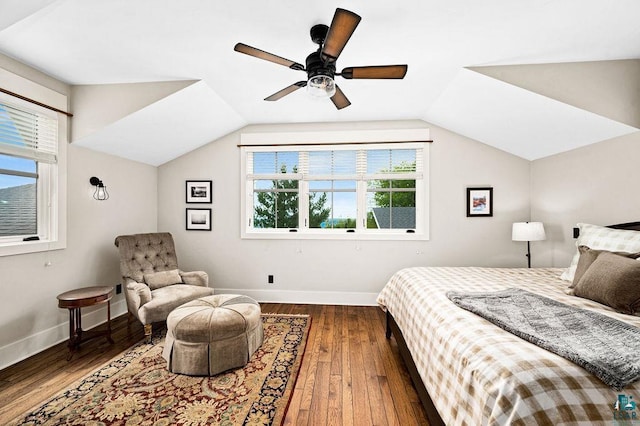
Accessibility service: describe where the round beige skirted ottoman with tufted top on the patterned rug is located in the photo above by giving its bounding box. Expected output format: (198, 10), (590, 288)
(162, 294), (263, 376)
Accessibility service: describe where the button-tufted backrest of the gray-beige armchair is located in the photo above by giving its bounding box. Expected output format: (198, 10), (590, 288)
(115, 232), (178, 282)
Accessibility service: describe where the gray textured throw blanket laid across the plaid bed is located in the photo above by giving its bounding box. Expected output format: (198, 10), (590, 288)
(447, 288), (640, 391)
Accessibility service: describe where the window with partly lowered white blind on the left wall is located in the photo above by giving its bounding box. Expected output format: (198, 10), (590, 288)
(0, 96), (58, 254)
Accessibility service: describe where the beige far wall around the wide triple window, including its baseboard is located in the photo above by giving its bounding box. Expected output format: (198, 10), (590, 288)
(158, 121), (530, 303)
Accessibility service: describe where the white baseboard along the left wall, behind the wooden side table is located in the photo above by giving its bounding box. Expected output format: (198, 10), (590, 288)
(0, 299), (127, 370)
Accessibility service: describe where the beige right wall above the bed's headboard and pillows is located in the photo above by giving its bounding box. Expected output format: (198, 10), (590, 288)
(531, 132), (640, 267)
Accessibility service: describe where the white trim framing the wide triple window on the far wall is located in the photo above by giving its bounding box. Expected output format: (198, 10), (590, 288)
(238, 128), (431, 240)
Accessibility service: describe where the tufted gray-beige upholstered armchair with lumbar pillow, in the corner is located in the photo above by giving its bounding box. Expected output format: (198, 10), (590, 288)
(115, 232), (213, 338)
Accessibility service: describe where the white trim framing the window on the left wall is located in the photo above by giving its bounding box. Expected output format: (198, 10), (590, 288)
(0, 75), (68, 256)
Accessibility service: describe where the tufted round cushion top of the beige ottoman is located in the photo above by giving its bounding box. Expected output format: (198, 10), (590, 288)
(167, 294), (261, 343)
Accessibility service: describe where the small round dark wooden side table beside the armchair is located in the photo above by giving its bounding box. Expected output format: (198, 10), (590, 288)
(58, 286), (113, 360)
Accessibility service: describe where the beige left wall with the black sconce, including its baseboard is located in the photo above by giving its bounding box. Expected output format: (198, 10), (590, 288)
(0, 55), (157, 369)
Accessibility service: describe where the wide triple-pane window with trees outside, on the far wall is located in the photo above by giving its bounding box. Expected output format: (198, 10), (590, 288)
(241, 142), (428, 239)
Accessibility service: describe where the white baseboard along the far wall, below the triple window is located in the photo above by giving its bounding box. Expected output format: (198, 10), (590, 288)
(215, 288), (378, 306)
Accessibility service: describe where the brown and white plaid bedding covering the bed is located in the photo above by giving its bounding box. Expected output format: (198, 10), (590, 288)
(378, 267), (640, 425)
